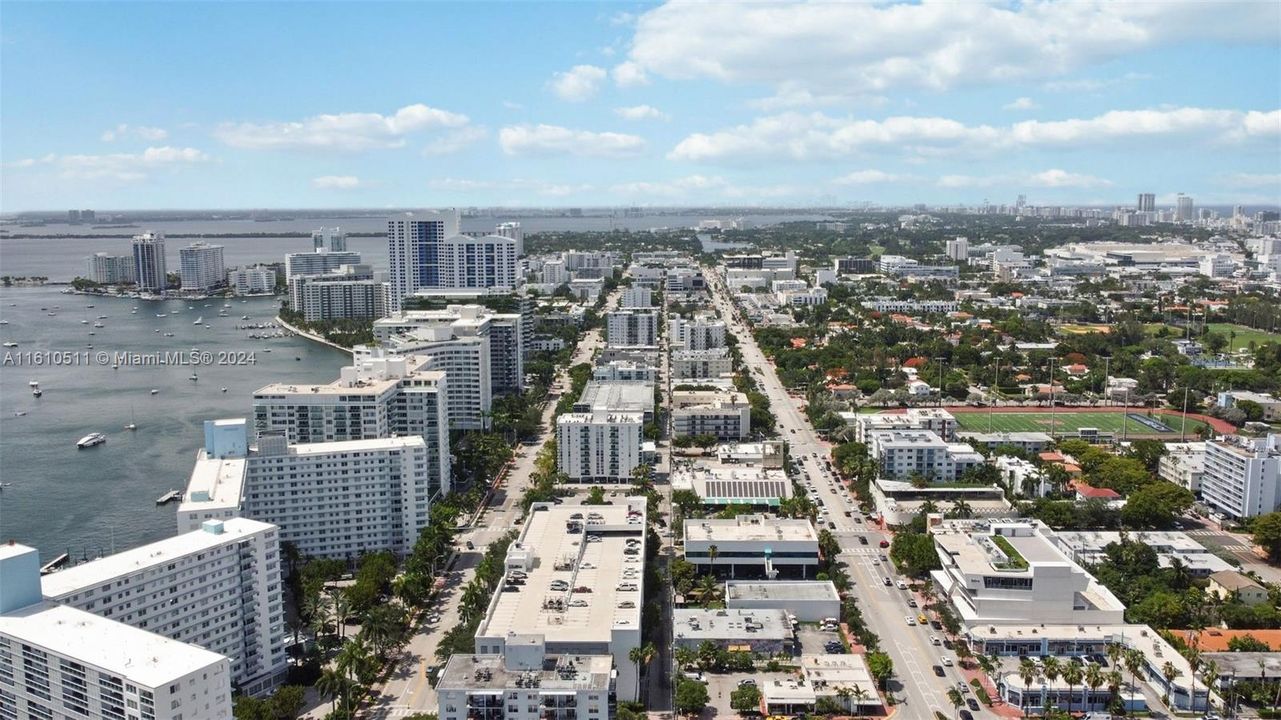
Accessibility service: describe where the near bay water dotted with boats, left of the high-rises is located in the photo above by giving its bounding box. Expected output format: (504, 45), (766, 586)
(0, 287), (347, 560)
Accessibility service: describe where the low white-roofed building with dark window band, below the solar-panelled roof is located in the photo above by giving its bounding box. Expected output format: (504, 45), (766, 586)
(684, 515), (819, 580)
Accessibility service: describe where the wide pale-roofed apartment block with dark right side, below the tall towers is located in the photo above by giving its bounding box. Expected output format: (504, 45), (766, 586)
(374, 305), (526, 395)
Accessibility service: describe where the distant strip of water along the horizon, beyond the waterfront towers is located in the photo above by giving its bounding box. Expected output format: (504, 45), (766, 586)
(0, 211), (826, 282)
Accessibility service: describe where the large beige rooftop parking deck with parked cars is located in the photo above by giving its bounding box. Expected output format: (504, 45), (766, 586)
(475, 497), (646, 643)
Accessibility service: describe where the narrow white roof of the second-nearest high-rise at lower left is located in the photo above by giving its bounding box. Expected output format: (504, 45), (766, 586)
(40, 518), (275, 600)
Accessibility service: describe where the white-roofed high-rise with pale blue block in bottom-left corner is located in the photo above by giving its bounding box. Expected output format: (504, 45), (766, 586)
(0, 542), (232, 720)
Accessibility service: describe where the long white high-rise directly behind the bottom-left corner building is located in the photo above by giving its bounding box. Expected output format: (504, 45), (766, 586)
(41, 518), (288, 694)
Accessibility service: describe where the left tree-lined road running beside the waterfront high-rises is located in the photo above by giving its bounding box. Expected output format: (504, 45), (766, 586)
(361, 291), (621, 719)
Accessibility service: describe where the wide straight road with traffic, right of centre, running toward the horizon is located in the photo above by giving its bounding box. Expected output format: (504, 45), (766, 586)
(708, 274), (994, 717)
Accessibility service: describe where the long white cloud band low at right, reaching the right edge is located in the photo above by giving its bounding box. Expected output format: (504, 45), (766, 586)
(669, 108), (1281, 161)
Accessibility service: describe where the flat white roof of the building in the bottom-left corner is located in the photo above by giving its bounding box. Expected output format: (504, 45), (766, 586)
(0, 602), (229, 688)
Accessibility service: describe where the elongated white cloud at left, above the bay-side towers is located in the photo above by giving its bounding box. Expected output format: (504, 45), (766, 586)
(214, 104), (468, 152)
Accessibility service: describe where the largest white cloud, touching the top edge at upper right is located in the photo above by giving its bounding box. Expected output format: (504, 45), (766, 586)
(617, 0), (1281, 95)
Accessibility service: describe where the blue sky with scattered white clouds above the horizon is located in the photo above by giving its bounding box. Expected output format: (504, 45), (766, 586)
(0, 0), (1281, 213)
